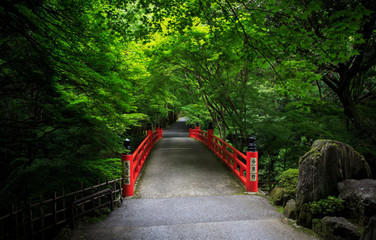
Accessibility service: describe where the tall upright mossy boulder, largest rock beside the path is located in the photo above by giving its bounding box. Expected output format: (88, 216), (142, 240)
(296, 140), (371, 227)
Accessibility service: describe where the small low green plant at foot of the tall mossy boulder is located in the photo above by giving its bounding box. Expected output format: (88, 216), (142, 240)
(309, 196), (345, 216)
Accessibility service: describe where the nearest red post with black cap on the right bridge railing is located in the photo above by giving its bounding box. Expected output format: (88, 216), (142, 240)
(245, 137), (258, 192)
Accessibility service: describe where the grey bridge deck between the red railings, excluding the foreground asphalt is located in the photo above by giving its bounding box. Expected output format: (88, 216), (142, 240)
(136, 118), (245, 198)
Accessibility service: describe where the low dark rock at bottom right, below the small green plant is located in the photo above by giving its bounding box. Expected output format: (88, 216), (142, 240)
(313, 217), (360, 240)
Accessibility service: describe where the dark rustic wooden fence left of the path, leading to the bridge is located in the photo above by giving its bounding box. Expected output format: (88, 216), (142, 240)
(0, 178), (122, 240)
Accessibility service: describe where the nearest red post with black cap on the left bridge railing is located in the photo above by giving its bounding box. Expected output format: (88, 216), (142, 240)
(121, 139), (134, 197)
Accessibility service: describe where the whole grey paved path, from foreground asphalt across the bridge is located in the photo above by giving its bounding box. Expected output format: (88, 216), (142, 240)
(72, 119), (316, 240)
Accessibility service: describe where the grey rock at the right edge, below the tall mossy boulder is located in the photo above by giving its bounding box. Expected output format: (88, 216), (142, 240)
(338, 179), (376, 226)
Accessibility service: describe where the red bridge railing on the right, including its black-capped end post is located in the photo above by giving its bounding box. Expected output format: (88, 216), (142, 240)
(189, 124), (258, 192)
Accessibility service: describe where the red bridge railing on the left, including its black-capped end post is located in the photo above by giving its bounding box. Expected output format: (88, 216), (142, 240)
(121, 124), (163, 197)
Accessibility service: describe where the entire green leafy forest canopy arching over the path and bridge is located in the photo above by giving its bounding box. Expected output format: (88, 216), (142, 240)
(0, 0), (376, 209)
